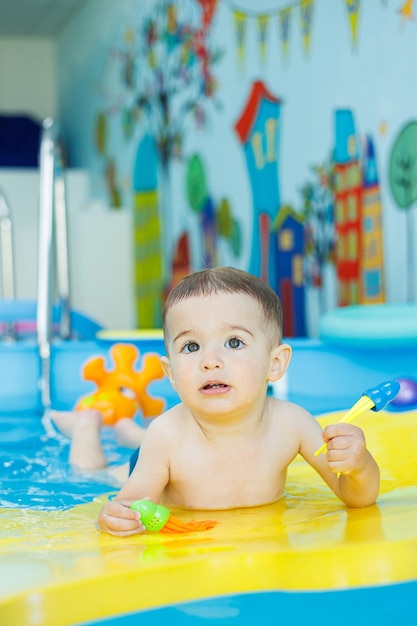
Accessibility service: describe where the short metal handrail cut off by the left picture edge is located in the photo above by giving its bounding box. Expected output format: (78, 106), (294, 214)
(0, 189), (16, 340)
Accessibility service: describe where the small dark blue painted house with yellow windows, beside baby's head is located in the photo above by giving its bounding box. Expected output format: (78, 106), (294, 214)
(273, 207), (306, 337)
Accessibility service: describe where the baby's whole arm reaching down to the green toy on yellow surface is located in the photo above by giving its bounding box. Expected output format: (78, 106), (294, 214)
(97, 425), (169, 537)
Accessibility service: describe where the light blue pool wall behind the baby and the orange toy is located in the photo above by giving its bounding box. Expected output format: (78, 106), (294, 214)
(0, 338), (417, 415)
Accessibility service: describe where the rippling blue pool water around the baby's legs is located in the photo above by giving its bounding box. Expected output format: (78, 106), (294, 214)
(0, 415), (127, 511)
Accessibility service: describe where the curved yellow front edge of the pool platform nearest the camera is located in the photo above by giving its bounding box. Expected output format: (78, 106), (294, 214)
(0, 539), (417, 626)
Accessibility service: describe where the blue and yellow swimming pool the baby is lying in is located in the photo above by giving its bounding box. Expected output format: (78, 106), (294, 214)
(0, 342), (417, 626)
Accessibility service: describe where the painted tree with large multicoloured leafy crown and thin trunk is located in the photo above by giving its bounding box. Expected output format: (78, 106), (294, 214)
(122, 0), (221, 285)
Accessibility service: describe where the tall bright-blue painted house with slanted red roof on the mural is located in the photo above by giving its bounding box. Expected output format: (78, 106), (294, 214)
(235, 81), (281, 289)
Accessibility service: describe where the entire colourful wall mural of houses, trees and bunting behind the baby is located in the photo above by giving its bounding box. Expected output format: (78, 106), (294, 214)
(58, 0), (417, 336)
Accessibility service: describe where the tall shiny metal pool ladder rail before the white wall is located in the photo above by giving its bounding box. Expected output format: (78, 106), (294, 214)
(36, 118), (71, 409)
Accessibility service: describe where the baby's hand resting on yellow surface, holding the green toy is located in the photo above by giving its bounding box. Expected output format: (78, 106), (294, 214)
(97, 500), (146, 537)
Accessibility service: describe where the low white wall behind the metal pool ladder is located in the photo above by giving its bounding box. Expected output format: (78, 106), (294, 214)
(0, 169), (134, 329)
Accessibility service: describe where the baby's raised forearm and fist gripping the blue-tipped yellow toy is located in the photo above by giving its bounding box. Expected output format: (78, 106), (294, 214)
(300, 416), (380, 507)
